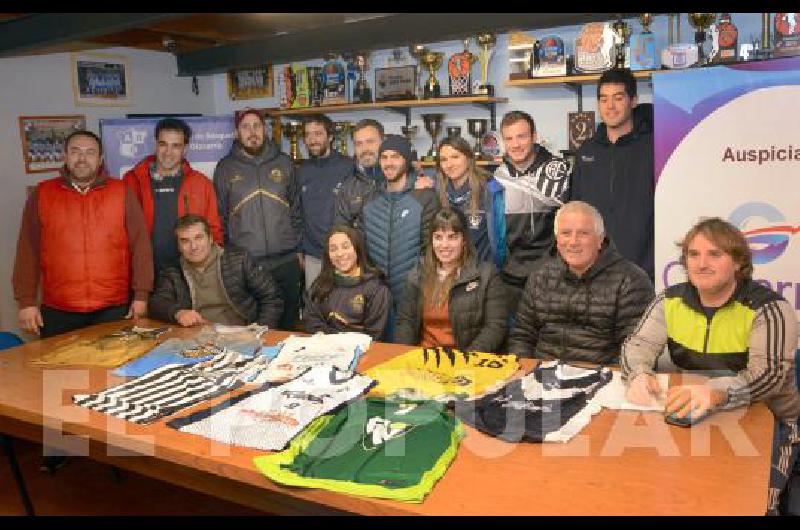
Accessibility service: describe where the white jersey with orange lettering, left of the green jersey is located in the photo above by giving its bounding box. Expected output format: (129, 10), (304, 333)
(167, 366), (374, 451)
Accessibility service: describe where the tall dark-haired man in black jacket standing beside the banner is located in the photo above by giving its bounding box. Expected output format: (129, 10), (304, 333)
(570, 70), (655, 281)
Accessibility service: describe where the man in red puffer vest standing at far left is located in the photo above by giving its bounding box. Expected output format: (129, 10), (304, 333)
(12, 131), (153, 338)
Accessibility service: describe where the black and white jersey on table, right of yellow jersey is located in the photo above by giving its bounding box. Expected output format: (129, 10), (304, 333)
(456, 361), (611, 442)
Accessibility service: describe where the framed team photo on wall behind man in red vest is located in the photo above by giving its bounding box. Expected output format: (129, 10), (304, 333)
(19, 114), (86, 173)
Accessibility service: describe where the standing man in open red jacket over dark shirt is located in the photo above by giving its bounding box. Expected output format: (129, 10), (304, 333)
(124, 118), (223, 275)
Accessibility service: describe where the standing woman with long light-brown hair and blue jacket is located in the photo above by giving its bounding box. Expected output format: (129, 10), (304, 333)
(436, 136), (506, 270)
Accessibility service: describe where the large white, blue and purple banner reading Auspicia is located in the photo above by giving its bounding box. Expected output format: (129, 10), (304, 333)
(653, 57), (800, 310)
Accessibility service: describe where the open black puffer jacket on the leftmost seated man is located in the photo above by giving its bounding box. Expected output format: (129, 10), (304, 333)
(148, 246), (283, 329)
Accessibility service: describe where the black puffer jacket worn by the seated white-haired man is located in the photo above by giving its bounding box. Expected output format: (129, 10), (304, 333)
(509, 238), (655, 363)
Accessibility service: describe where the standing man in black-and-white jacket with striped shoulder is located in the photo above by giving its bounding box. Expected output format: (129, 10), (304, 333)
(494, 110), (569, 314)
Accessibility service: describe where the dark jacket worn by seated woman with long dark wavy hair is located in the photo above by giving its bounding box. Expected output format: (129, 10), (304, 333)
(303, 272), (392, 340)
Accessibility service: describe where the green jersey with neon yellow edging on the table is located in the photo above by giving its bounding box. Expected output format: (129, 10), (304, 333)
(254, 399), (465, 502)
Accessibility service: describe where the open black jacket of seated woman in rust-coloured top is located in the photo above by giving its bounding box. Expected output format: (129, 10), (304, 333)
(394, 258), (508, 353)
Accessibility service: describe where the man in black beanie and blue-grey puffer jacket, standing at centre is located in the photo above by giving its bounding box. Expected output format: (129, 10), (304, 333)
(363, 134), (439, 341)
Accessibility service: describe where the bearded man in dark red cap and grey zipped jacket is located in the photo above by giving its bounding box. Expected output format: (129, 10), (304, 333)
(214, 109), (302, 330)
